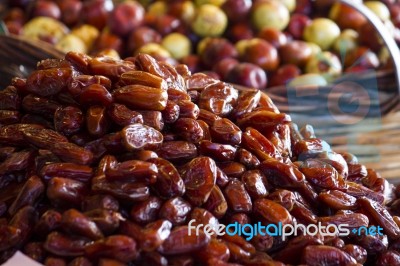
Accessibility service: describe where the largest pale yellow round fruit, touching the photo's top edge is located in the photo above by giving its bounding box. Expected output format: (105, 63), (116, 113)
(251, 0), (290, 31)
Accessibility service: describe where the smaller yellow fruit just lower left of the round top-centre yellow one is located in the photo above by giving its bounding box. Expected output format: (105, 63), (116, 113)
(161, 32), (192, 60)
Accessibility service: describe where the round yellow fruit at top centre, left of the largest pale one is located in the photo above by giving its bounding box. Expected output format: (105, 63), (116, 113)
(192, 4), (228, 37)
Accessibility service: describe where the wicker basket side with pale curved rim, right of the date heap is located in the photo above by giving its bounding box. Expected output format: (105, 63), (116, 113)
(267, 0), (400, 183)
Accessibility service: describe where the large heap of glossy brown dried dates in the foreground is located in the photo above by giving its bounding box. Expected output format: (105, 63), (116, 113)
(0, 52), (400, 265)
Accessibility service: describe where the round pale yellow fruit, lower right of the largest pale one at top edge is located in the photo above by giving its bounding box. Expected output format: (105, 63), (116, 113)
(303, 18), (340, 50)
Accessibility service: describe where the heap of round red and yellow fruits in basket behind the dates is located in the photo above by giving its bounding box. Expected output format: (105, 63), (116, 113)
(4, 0), (400, 89)
